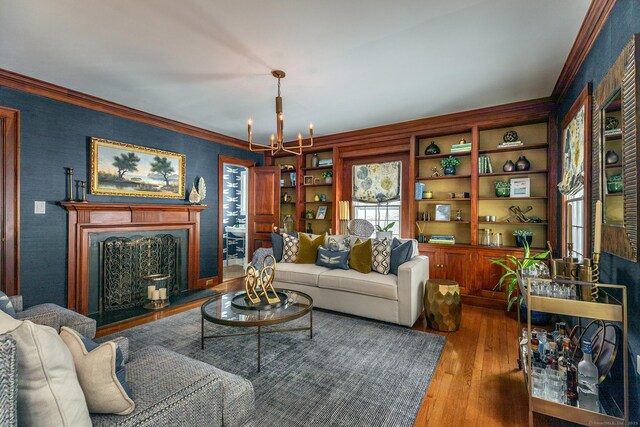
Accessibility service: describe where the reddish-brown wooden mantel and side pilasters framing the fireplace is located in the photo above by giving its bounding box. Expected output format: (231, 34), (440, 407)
(60, 202), (207, 314)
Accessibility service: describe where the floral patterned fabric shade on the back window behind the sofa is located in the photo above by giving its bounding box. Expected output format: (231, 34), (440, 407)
(352, 161), (402, 203)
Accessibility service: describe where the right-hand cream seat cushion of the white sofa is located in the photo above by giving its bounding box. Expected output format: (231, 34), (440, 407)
(318, 270), (398, 300)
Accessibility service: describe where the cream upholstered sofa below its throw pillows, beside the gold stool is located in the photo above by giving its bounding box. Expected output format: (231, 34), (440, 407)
(274, 255), (429, 327)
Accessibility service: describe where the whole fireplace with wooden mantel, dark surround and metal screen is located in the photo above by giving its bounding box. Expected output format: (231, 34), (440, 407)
(61, 202), (207, 314)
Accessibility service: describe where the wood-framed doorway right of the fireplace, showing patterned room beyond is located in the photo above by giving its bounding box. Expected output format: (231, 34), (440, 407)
(218, 156), (255, 282)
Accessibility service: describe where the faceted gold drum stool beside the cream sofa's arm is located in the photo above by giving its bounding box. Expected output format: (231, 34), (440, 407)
(424, 279), (462, 332)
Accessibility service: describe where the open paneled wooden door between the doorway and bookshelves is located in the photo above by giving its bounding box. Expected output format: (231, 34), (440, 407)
(247, 166), (280, 259)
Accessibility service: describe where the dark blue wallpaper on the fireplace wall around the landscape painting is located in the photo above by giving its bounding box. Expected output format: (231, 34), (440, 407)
(0, 87), (264, 306)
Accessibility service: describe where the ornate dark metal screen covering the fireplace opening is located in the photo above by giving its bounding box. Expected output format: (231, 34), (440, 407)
(100, 234), (181, 312)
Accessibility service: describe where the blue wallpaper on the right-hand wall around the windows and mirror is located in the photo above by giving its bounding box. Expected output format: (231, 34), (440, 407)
(557, 0), (640, 420)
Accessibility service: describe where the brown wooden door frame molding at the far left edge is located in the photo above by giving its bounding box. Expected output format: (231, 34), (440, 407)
(0, 107), (20, 295)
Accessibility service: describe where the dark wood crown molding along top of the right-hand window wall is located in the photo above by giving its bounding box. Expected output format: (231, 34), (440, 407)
(551, 0), (616, 102)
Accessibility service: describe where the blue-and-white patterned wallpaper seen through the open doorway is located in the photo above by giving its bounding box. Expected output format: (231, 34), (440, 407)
(222, 164), (249, 260)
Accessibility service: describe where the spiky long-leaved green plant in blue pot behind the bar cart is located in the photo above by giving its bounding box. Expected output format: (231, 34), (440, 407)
(491, 244), (549, 324)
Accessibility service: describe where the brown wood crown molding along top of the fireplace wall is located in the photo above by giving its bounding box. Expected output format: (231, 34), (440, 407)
(0, 68), (248, 150)
